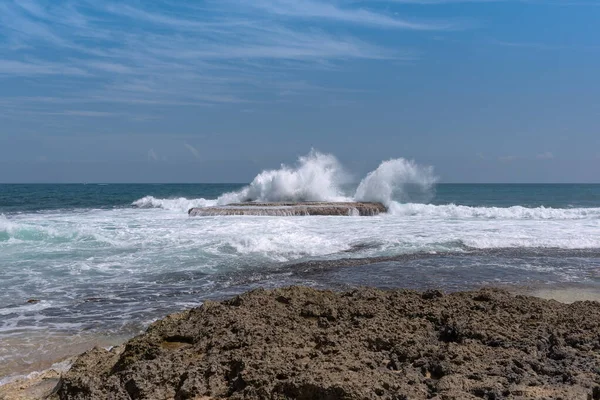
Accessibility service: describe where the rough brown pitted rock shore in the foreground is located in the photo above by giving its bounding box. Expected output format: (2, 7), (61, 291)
(54, 287), (600, 400)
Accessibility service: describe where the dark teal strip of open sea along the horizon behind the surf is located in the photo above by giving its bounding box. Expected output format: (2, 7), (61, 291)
(0, 184), (600, 213)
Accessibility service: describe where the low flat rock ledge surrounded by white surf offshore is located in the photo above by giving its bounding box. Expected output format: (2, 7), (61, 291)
(188, 202), (387, 217)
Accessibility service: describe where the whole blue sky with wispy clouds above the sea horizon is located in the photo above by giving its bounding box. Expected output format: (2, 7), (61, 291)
(0, 0), (600, 183)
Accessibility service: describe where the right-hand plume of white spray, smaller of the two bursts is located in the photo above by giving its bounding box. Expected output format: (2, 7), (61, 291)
(354, 158), (437, 207)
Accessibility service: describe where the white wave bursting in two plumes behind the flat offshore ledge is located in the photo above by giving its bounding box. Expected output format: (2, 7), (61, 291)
(133, 150), (436, 211)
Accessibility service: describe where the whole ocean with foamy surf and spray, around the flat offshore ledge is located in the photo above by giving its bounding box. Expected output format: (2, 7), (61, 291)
(0, 153), (600, 381)
